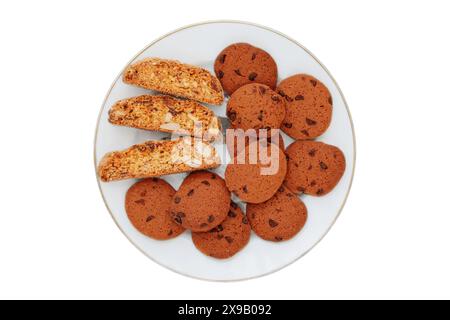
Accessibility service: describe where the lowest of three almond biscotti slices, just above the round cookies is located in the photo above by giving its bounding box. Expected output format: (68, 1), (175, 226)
(98, 137), (220, 182)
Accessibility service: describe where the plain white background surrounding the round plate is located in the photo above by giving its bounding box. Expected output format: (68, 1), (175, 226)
(0, 0), (450, 299)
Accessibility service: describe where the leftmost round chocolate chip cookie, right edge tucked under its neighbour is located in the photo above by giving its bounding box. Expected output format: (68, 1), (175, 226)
(125, 178), (184, 240)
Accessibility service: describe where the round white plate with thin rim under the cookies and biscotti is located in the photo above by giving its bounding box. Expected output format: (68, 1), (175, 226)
(94, 21), (355, 281)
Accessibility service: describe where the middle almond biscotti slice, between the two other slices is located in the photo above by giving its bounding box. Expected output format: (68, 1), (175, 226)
(109, 95), (220, 141)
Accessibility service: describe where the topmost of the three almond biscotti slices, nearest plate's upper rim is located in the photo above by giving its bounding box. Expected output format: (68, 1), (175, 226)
(123, 58), (223, 105)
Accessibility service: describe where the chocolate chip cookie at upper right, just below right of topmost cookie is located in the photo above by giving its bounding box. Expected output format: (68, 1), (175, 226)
(277, 74), (333, 140)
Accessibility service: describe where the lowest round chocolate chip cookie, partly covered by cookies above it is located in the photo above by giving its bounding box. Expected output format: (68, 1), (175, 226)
(192, 202), (251, 259)
